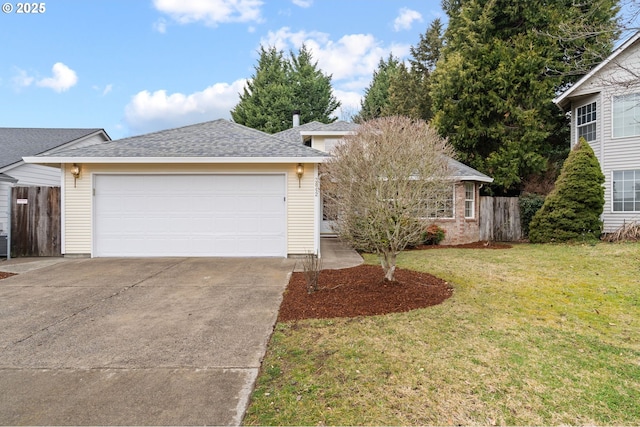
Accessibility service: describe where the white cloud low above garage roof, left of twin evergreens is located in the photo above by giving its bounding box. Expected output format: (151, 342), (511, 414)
(125, 79), (246, 134)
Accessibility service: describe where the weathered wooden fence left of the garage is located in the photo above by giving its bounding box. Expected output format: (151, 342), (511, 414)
(11, 187), (61, 257)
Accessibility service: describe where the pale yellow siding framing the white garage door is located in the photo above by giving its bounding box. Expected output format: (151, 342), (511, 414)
(64, 164), (315, 254)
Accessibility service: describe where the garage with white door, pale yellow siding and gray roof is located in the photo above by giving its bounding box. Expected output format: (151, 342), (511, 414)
(24, 119), (328, 257)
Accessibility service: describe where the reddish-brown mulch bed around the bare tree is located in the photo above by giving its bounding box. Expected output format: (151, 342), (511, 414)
(278, 265), (453, 322)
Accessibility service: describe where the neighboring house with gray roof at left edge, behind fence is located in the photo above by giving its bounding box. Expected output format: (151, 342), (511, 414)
(0, 128), (110, 256)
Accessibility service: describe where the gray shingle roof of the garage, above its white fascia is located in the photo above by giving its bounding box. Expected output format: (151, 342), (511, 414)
(50, 119), (326, 158)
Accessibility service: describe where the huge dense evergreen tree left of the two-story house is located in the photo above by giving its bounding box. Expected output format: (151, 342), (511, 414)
(431, 0), (617, 193)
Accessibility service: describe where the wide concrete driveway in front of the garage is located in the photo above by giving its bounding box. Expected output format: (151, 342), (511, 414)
(0, 258), (294, 425)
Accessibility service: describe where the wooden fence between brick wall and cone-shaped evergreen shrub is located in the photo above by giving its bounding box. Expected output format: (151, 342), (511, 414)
(480, 196), (522, 242)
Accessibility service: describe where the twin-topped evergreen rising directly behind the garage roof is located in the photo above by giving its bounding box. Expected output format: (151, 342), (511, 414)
(231, 46), (340, 133)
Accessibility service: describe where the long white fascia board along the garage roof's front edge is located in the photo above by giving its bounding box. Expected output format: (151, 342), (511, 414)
(22, 156), (326, 164)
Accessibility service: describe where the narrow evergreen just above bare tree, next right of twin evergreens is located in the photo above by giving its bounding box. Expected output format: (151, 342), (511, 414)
(353, 55), (400, 122)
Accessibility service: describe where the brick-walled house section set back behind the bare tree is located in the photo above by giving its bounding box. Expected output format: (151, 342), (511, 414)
(275, 119), (493, 244)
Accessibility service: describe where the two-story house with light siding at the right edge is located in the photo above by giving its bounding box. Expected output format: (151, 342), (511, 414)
(554, 32), (640, 232)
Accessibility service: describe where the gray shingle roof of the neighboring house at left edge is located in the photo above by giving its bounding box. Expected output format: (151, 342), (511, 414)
(0, 128), (102, 168)
